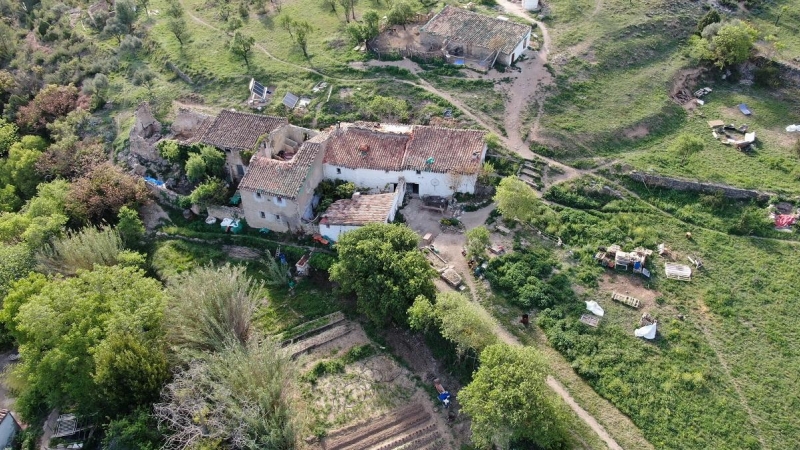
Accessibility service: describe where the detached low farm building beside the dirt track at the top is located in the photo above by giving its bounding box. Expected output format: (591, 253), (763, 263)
(420, 5), (531, 67)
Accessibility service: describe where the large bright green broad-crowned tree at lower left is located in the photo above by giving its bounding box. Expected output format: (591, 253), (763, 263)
(9, 266), (169, 420)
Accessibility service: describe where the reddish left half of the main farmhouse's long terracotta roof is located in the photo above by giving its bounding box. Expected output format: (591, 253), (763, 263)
(324, 124), (410, 171)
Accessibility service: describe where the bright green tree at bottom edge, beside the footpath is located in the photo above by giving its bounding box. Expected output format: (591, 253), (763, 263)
(458, 344), (569, 449)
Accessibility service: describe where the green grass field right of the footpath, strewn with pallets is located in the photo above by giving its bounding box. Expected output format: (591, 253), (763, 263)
(492, 178), (800, 449)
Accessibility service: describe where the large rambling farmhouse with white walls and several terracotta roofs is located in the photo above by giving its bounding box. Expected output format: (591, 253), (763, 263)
(208, 118), (487, 232)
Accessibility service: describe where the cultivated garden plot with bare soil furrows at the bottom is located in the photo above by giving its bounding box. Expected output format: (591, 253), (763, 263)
(288, 315), (451, 450)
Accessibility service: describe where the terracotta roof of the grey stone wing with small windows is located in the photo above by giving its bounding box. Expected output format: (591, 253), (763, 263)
(239, 133), (327, 199)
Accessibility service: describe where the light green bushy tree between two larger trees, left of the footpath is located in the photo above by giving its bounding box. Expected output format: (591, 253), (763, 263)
(408, 292), (497, 355)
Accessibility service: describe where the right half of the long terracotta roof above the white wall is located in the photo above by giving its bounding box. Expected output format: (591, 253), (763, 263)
(403, 126), (486, 174)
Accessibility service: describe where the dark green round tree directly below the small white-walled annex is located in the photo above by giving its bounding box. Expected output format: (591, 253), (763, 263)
(330, 224), (436, 324)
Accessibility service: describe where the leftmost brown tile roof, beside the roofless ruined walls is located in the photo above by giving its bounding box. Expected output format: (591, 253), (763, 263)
(200, 110), (289, 150)
